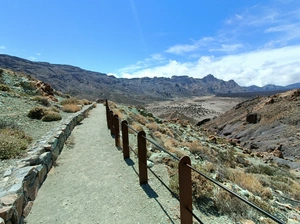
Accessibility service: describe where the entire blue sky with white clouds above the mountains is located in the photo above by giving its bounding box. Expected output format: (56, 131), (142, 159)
(0, 0), (300, 86)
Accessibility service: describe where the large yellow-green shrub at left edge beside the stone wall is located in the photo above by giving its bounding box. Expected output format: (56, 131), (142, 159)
(0, 128), (32, 159)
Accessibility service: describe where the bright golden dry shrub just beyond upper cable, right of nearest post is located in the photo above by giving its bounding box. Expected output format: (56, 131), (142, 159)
(232, 170), (264, 195)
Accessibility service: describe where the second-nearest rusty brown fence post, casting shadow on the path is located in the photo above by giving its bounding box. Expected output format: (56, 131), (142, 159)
(138, 131), (148, 185)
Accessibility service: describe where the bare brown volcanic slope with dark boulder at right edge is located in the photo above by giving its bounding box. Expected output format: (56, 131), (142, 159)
(203, 89), (300, 161)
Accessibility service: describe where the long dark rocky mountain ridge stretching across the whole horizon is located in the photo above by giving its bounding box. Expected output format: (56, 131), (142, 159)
(0, 54), (300, 104)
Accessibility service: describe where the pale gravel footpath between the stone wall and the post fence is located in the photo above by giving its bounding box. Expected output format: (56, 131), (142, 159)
(25, 104), (179, 224)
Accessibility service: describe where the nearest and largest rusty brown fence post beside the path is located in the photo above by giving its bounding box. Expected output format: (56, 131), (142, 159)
(178, 156), (193, 224)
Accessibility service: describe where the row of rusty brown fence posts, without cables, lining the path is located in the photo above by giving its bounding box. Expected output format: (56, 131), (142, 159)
(105, 100), (193, 224)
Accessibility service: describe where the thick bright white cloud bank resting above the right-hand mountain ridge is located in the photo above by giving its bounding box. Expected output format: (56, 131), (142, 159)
(121, 45), (300, 86)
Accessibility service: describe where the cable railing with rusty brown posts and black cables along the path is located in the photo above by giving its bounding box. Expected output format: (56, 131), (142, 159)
(106, 101), (284, 224)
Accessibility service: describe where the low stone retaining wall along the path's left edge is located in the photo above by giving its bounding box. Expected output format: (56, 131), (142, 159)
(0, 105), (94, 224)
